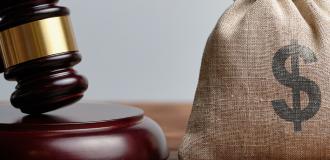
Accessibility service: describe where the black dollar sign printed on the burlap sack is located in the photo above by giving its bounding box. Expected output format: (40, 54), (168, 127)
(272, 41), (321, 132)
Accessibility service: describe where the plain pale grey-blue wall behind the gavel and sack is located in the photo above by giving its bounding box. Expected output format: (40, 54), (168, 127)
(0, 0), (232, 102)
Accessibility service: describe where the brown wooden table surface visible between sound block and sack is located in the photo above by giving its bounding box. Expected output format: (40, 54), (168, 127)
(122, 103), (192, 160)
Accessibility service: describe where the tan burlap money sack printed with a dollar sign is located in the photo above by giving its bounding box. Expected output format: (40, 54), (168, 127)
(179, 0), (330, 160)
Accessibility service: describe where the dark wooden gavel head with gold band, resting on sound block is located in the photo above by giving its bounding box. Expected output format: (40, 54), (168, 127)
(0, 0), (88, 114)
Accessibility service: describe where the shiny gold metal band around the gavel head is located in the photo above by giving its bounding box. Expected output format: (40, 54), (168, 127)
(0, 16), (78, 68)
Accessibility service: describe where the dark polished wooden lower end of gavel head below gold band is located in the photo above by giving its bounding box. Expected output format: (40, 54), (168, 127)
(5, 53), (88, 114)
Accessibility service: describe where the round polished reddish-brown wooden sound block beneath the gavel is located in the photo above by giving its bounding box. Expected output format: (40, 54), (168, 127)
(0, 103), (168, 160)
